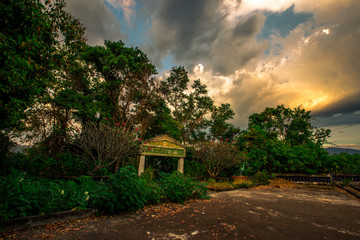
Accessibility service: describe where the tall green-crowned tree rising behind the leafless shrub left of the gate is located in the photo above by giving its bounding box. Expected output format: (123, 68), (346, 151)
(83, 41), (159, 136)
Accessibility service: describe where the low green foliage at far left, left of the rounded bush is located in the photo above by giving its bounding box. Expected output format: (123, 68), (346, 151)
(0, 171), (89, 221)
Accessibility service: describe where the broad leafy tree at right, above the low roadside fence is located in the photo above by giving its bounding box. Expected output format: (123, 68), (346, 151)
(238, 105), (330, 174)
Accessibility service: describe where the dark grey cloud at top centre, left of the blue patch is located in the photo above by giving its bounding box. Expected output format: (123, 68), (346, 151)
(149, 0), (265, 74)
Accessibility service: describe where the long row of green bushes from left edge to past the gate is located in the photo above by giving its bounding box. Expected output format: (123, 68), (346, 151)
(0, 167), (208, 221)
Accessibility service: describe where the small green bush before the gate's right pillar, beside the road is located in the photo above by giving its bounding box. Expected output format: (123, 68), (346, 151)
(159, 172), (208, 203)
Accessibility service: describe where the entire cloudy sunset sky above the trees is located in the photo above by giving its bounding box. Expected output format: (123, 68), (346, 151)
(66, 0), (360, 150)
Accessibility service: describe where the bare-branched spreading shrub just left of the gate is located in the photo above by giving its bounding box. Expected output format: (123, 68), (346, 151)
(74, 123), (140, 175)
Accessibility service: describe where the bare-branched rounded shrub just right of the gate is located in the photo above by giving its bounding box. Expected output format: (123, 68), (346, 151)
(195, 141), (245, 178)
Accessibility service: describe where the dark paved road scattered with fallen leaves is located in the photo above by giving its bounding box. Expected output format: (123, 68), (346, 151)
(4, 187), (360, 240)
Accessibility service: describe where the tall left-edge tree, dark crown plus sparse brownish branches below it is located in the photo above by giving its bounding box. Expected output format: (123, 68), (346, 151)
(0, 0), (86, 156)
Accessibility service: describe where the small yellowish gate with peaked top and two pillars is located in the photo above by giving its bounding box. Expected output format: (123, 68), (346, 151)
(138, 134), (186, 176)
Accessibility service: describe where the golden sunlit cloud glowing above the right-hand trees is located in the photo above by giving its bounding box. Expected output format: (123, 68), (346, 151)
(196, 2), (360, 129)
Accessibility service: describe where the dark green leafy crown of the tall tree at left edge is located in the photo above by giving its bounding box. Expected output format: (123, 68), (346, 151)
(0, 0), (83, 130)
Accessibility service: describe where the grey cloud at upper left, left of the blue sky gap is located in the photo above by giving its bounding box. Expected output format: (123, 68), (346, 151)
(66, 0), (125, 45)
